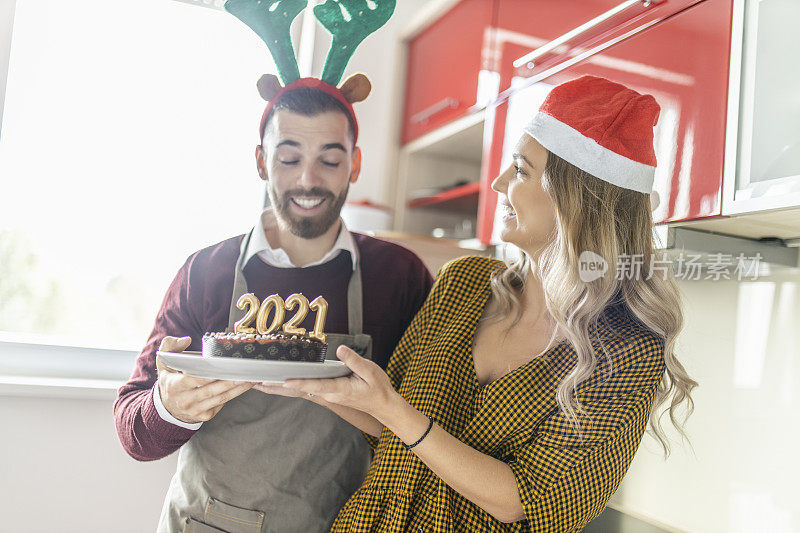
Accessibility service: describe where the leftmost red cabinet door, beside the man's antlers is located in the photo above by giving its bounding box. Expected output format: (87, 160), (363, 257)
(401, 0), (494, 144)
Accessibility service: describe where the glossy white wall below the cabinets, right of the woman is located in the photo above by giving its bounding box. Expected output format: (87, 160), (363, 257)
(612, 270), (800, 533)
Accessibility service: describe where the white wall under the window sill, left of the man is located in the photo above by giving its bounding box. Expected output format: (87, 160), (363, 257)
(0, 391), (177, 533)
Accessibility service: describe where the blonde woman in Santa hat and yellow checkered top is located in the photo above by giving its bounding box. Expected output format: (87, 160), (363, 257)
(262, 76), (696, 532)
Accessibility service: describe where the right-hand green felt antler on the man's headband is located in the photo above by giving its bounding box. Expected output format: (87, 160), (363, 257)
(314, 0), (396, 85)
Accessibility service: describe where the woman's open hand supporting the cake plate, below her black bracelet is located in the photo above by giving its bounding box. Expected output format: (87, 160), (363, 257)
(276, 346), (400, 420)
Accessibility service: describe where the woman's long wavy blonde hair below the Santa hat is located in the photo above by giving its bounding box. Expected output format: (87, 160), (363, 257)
(486, 152), (697, 456)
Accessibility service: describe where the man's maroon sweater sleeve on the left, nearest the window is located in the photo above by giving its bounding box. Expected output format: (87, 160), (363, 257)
(114, 255), (202, 461)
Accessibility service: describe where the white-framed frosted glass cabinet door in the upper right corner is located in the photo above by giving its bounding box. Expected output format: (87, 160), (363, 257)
(724, 0), (800, 214)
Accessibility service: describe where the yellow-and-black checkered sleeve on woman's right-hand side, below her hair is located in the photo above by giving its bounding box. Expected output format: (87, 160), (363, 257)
(508, 334), (663, 532)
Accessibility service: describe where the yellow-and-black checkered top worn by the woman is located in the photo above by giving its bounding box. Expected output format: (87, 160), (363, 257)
(332, 257), (665, 533)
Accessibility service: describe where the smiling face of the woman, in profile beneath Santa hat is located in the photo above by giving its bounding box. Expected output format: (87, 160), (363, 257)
(492, 134), (556, 256)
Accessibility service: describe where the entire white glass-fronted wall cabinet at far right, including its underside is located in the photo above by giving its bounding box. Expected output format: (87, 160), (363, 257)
(684, 0), (800, 240)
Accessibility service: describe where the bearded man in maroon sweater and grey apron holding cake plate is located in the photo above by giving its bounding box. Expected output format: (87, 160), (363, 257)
(114, 84), (432, 533)
